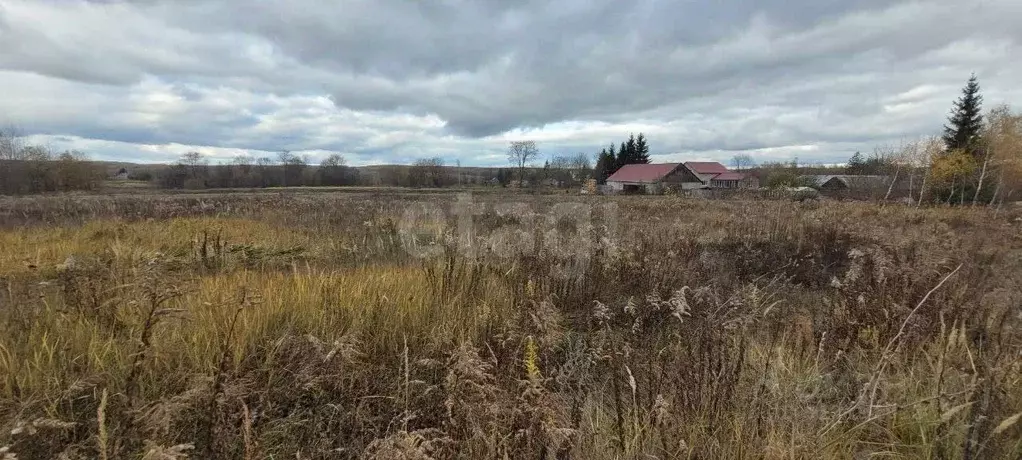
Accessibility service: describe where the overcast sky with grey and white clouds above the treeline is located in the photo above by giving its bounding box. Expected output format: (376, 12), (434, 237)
(0, 0), (1022, 166)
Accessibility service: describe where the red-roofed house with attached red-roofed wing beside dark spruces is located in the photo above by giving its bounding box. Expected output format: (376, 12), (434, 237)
(607, 162), (759, 193)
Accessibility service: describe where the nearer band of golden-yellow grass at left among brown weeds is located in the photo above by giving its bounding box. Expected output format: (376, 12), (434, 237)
(0, 261), (510, 398)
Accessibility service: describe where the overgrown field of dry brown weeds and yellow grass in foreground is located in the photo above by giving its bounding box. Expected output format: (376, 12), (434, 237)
(0, 189), (1022, 460)
